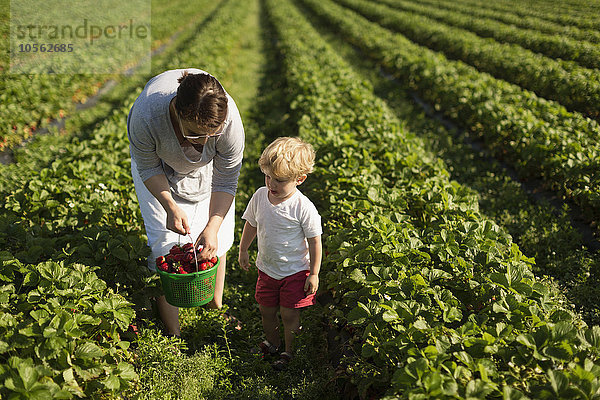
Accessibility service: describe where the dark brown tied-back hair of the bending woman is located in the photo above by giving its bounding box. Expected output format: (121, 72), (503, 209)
(175, 71), (227, 130)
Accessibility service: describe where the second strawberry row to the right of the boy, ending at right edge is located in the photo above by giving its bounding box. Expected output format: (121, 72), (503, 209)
(304, 0), (600, 227)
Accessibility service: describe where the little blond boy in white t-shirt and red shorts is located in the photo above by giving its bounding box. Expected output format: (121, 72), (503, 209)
(238, 137), (323, 370)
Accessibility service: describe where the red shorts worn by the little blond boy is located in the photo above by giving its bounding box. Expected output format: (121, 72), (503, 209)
(254, 270), (316, 308)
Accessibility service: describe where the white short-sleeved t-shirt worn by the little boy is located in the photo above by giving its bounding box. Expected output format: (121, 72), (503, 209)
(242, 186), (323, 279)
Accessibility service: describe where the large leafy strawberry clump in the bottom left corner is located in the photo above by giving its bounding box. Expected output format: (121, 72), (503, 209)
(0, 252), (137, 398)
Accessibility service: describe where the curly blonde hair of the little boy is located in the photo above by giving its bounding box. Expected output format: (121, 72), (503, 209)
(258, 136), (315, 180)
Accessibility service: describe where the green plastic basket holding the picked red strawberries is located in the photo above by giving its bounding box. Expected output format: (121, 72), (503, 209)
(158, 258), (221, 307)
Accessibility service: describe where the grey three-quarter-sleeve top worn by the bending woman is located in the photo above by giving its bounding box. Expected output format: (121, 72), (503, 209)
(127, 68), (244, 202)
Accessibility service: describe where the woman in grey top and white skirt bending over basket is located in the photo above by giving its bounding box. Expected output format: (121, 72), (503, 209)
(127, 68), (244, 336)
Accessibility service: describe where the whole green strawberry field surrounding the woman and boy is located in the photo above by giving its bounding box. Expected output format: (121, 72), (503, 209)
(0, 0), (600, 399)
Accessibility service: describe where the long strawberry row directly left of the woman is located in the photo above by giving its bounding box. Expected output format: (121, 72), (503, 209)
(0, 1), (247, 398)
